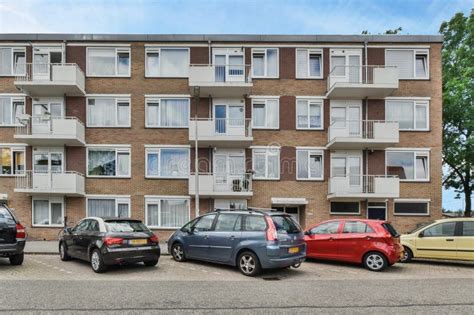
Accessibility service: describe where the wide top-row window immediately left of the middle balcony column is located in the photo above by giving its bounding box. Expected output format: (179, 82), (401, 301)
(145, 48), (189, 78)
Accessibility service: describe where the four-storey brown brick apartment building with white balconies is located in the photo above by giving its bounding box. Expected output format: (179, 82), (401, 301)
(0, 34), (442, 239)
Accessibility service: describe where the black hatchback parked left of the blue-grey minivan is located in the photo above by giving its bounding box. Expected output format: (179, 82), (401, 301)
(59, 217), (160, 273)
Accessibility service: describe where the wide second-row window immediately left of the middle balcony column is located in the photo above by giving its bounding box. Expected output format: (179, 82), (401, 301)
(145, 98), (189, 128)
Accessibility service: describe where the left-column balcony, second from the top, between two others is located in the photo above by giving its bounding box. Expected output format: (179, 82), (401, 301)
(14, 115), (86, 146)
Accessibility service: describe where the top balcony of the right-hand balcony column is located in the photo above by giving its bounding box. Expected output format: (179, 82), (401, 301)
(326, 66), (398, 99)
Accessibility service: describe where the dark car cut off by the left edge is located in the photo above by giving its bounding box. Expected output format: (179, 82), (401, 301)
(0, 204), (26, 266)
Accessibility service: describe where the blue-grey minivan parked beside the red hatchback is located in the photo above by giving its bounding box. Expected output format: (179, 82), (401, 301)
(168, 210), (306, 276)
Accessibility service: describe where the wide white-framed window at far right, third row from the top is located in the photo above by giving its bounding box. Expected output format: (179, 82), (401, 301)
(386, 151), (429, 181)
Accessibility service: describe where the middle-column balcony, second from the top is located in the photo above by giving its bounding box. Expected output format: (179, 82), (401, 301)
(189, 118), (253, 147)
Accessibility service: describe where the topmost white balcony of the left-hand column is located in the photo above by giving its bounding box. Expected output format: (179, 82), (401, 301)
(15, 63), (86, 97)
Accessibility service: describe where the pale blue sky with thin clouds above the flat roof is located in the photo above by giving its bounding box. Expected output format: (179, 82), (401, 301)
(0, 0), (474, 210)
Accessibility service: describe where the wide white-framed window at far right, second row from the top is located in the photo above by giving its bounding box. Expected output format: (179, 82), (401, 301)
(385, 100), (429, 130)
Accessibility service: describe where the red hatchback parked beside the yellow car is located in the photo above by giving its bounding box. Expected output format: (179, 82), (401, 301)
(305, 219), (403, 271)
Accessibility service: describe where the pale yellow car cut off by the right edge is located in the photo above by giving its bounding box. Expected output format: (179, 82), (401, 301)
(400, 218), (474, 262)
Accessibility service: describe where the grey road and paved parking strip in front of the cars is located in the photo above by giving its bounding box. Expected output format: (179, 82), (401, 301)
(0, 255), (474, 314)
